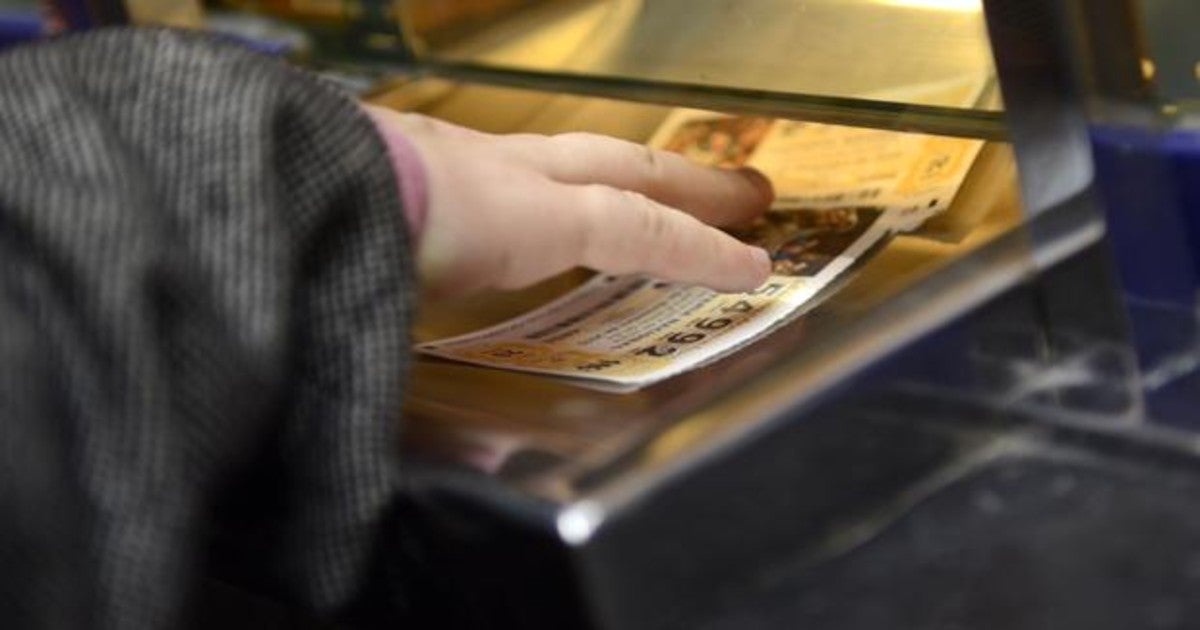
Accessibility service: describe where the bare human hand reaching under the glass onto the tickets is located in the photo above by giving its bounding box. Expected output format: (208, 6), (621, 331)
(366, 106), (774, 298)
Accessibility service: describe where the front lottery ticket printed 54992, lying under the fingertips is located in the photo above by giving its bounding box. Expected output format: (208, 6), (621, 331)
(418, 208), (890, 389)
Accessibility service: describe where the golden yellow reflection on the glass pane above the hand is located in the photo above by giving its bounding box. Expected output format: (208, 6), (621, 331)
(401, 0), (996, 108)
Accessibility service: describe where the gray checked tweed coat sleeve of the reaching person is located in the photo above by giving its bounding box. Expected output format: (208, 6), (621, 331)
(0, 30), (413, 628)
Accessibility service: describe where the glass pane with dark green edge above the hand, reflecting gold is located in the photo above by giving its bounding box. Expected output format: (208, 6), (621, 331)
(222, 0), (1004, 139)
